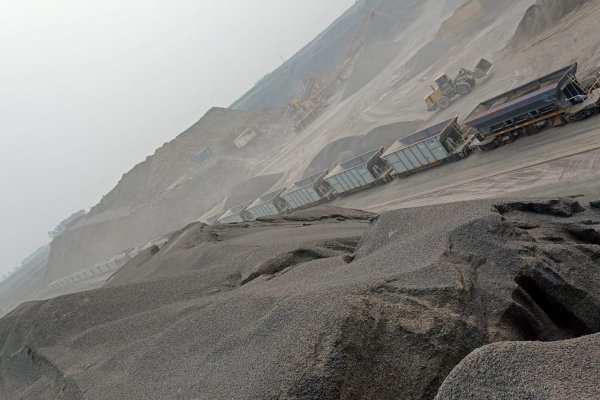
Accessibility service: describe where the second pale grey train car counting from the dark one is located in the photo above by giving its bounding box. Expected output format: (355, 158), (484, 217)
(325, 147), (392, 195)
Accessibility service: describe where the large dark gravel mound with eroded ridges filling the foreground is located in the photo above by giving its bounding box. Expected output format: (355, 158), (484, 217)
(0, 200), (600, 399)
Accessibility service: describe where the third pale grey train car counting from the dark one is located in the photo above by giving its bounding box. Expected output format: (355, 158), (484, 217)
(280, 170), (332, 211)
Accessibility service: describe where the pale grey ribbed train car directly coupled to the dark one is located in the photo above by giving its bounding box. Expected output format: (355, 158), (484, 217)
(381, 117), (470, 175)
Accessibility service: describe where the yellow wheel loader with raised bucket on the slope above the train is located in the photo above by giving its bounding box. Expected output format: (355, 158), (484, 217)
(425, 58), (494, 112)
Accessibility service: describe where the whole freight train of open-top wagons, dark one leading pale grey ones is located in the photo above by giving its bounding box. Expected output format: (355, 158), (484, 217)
(211, 63), (600, 224)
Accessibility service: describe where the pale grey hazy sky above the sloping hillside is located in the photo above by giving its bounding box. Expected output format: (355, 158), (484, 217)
(0, 0), (354, 276)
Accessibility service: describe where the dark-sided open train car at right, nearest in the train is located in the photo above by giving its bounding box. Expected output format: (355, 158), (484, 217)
(465, 63), (598, 150)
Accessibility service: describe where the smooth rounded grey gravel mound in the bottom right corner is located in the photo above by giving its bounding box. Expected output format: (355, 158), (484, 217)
(436, 335), (600, 400)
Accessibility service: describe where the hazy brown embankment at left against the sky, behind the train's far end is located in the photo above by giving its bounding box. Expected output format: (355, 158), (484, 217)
(41, 108), (288, 282)
